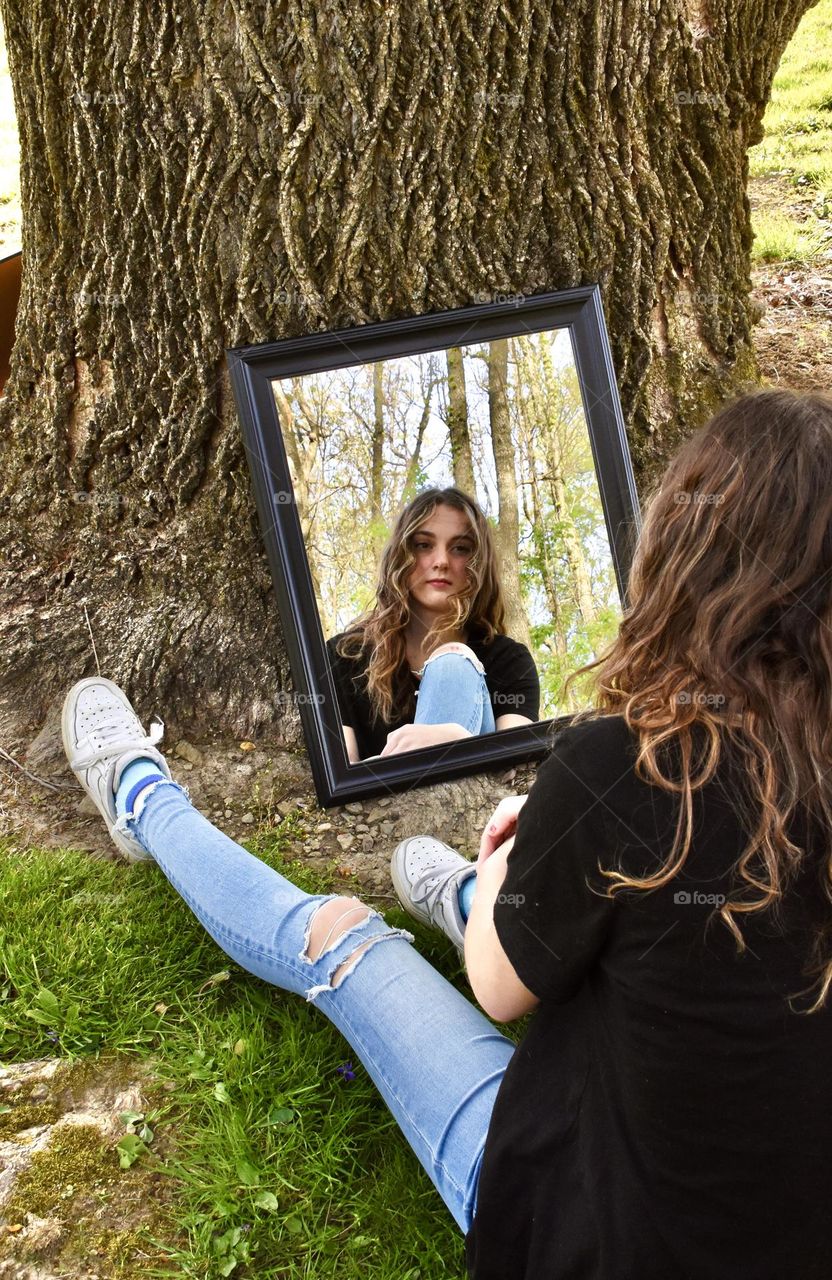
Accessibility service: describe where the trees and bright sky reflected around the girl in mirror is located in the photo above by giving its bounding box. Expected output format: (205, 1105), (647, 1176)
(271, 328), (621, 759)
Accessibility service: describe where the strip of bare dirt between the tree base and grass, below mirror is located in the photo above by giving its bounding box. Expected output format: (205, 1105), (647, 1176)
(0, 711), (527, 905)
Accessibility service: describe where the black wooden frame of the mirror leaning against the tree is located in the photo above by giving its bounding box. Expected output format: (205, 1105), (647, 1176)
(227, 285), (640, 806)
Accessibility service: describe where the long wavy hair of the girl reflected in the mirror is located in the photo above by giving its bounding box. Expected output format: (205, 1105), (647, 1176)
(337, 485), (506, 723)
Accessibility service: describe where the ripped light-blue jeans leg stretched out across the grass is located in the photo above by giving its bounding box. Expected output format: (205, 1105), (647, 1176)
(125, 781), (515, 1233)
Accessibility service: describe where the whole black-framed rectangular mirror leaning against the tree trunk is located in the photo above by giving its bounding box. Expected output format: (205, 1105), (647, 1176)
(229, 288), (637, 804)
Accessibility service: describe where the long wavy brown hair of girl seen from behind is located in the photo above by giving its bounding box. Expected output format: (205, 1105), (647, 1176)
(558, 390), (832, 1014)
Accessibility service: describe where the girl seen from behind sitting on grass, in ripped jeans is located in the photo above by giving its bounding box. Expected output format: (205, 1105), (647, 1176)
(64, 390), (832, 1280)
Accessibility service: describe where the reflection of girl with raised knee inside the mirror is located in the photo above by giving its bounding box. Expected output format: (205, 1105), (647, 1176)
(326, 486), (540, 763)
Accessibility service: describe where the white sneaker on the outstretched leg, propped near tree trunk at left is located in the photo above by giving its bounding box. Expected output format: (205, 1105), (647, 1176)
(61, 676), (173, 861)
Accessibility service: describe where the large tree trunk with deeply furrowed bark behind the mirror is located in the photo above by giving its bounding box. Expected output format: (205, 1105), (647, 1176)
(0, 0), (808, 744)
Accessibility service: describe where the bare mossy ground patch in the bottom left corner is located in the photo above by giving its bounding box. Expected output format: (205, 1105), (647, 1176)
(0, 1059), (179, 1280)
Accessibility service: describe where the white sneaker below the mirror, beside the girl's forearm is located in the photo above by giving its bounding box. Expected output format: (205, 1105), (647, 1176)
(390, 836), (476, 955)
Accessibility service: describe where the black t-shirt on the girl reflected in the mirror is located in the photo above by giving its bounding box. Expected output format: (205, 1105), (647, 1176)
(326, 631), (540, 759)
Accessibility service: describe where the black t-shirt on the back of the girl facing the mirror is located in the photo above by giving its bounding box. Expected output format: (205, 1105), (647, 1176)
(466, 716), (832, 1280)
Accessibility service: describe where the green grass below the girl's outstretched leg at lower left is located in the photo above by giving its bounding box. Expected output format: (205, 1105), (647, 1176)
(0, 823), (504, 1280)
